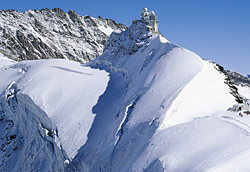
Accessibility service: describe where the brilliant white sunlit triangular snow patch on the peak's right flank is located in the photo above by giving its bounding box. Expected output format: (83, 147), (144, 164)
(161, 61), (235, 129)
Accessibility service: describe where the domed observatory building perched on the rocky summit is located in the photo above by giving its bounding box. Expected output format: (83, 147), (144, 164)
(141, 8), (159, 33)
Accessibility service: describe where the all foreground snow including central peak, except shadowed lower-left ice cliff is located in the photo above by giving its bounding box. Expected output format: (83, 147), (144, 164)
(0, 21), (250, 172)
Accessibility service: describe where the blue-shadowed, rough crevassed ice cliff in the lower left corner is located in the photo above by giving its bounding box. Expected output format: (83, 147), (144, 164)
(0, 94), (65, 171)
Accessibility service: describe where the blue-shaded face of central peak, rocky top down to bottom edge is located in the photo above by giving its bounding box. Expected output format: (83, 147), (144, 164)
(70, 22), (207, 171)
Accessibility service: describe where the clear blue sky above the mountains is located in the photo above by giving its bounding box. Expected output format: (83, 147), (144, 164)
(0, 0), (250, 75)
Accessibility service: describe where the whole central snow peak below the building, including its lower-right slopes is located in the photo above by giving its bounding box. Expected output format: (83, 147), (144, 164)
(67, 21), (246, 172)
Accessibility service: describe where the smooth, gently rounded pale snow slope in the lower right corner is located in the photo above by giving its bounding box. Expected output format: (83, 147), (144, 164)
(132, 116), (250, 172)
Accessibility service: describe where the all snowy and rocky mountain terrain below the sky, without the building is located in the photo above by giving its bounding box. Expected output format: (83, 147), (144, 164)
(0, 9), (250, 172)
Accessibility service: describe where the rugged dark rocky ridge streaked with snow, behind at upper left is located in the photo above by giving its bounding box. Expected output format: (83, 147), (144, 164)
(0, 8), (126, 62)
